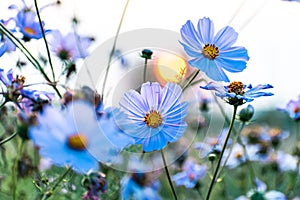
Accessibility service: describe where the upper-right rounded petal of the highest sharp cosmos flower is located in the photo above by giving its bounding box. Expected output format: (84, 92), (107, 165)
(213, 26), (238, 50)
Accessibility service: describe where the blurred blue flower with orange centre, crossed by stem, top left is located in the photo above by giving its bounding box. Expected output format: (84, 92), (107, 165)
(15, 10), (50, 41)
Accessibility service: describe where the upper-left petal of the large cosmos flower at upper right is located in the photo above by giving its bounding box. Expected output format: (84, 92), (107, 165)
(180, 20), (204, 50)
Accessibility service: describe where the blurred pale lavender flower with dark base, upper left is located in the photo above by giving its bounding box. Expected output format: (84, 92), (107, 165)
(49, 30), (92, 62)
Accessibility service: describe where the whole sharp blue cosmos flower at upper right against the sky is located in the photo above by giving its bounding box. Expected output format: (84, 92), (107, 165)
(180, 17), (249, 82)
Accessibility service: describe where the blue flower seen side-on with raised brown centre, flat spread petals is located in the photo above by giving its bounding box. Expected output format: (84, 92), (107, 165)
(200, 81), (274, 105)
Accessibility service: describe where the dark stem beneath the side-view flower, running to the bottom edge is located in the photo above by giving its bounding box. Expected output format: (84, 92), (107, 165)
(206, 106), (238, 200)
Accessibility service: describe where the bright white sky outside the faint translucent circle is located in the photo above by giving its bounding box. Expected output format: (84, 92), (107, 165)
(0, 0), (300, 107)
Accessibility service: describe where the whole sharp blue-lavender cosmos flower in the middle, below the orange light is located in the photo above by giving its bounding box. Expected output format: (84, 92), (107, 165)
(118, 82), (187, 152)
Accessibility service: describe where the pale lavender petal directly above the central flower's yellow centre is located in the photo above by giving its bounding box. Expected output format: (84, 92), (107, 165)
(141, 82), (161, 110)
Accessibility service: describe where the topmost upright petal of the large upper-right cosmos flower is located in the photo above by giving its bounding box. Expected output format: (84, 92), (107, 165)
(198, 17), (214, 46)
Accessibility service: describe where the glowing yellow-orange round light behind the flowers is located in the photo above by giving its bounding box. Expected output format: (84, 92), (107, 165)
(153, 52), (188, 85)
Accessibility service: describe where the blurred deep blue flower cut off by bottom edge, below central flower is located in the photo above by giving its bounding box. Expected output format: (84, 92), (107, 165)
(121, 173), (160, 200)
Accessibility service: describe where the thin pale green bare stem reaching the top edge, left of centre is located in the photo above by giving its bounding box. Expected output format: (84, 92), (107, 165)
(101, 0), (130, 102)
